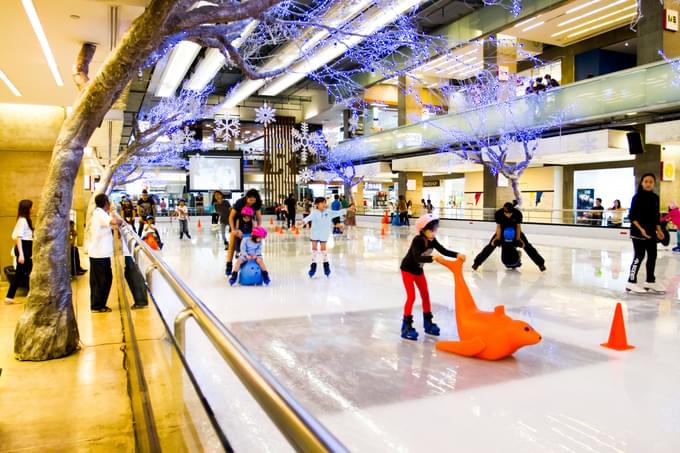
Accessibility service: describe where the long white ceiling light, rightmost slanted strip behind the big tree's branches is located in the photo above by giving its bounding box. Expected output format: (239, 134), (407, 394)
(260, 0), (423, 96)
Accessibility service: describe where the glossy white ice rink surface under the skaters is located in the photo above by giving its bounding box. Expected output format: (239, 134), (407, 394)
(150, 219), (680, 452)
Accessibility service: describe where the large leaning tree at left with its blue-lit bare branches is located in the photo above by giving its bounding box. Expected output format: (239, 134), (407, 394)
(14, 0), (472, 360)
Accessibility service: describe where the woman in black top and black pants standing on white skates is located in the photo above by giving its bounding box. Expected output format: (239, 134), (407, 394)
(626, 173), (665, 294)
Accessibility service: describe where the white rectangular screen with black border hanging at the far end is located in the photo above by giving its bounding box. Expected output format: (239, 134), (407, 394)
(189, 155), (243, 192)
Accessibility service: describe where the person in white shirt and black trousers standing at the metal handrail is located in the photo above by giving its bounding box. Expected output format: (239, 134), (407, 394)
(88, 193), (123, 313)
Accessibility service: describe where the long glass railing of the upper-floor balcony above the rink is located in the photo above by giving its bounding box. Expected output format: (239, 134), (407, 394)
(337, 61), (680, 161)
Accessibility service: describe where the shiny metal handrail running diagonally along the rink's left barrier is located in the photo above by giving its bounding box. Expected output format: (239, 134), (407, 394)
(117, 226), (348, 452)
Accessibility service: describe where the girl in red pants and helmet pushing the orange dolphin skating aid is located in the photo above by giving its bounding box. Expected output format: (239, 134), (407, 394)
(401, 214), (465, 341)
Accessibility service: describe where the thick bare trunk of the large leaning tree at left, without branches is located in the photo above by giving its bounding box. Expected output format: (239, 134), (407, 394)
(14, 0), (176, 360)
